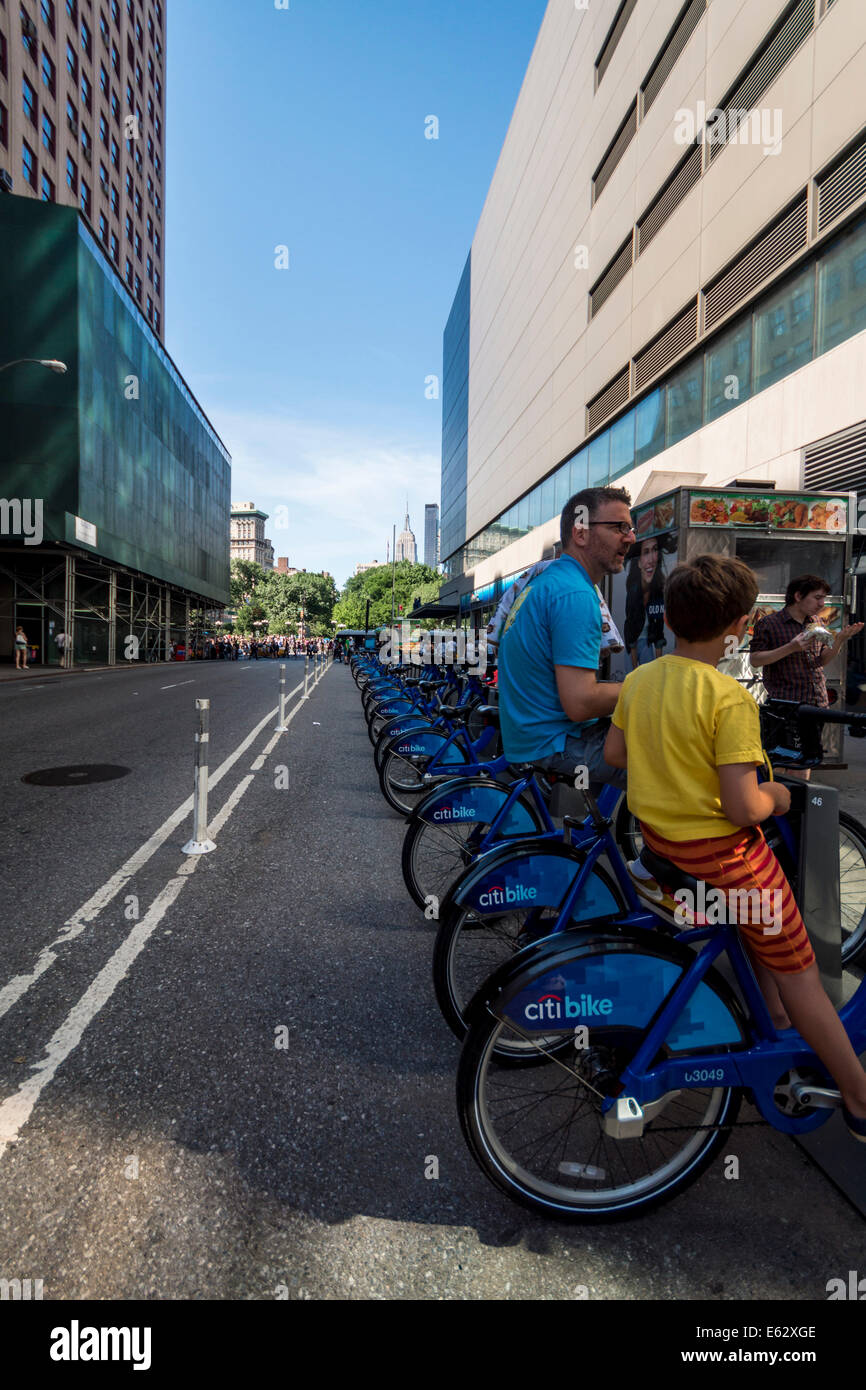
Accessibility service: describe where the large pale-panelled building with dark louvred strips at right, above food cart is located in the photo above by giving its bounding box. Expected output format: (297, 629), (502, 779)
(441, 0), (866, 647)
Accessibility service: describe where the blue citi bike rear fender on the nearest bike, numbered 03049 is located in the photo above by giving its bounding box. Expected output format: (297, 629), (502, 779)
(468, 933), (749, 1052)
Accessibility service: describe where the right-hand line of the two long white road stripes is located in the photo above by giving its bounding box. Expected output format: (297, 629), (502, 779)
(0, 687), (309, 1159)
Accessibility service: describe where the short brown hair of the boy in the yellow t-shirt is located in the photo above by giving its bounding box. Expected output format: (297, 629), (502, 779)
(664, 555), (758, 642)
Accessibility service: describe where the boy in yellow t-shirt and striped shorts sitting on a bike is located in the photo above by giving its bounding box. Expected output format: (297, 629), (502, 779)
(605, 555), (866, 1143)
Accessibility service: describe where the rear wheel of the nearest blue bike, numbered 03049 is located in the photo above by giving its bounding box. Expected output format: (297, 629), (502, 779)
(457, 1013), (741, 1222)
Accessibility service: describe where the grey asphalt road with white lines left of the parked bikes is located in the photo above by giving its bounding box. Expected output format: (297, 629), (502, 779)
(0, 662), (863, 1300)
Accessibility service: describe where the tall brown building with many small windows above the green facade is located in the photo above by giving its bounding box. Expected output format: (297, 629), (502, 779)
(0, 0), (167, 338)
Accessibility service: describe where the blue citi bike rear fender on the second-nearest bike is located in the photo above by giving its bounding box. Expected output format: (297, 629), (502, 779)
(449, 840), (623, 919)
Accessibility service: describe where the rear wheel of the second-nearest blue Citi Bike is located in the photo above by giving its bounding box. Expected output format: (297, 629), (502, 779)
(432, 865), (628, 1059)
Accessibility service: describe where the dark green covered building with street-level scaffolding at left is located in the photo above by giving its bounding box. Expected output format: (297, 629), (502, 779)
(0, 195), (231, 664)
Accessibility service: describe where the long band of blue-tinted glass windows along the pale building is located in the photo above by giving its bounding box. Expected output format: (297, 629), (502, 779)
(448, 207), (866, 575)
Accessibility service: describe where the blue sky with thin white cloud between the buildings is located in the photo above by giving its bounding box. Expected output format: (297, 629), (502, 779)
(164, 0), (546, 585)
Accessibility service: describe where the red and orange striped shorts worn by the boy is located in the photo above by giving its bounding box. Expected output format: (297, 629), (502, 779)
(641, 821), (815, 974)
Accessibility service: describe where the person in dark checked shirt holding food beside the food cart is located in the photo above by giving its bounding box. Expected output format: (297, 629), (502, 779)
(749, 574), (863, 781)
